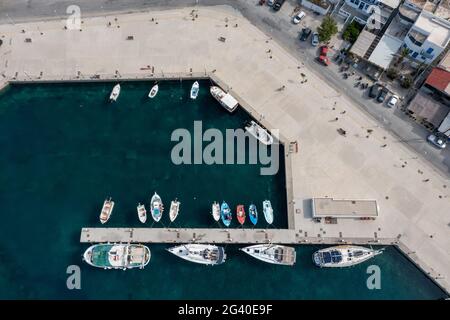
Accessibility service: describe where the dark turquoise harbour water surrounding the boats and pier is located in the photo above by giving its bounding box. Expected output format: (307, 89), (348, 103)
(0, 81), (444, 299)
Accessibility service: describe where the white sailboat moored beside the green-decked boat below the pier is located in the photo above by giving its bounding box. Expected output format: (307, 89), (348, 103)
(167, 243), (227, 265)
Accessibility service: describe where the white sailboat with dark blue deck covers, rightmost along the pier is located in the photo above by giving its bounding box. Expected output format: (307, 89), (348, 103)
(313, 245), (383, 268)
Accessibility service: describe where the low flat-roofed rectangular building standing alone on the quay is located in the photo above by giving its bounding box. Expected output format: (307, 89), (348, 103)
(312, 198), (379, 219)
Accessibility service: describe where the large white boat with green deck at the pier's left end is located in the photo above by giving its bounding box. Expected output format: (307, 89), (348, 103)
(83, 243), (151, 270)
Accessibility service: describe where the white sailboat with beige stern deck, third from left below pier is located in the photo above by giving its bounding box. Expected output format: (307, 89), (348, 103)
(239, 244), (296, 266)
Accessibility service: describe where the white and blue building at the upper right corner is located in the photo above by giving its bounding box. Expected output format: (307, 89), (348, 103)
(404, 10), (450, 64)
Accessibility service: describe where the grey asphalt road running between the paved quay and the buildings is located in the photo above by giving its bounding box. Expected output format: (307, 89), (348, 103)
(0, 0), (450, 177)
